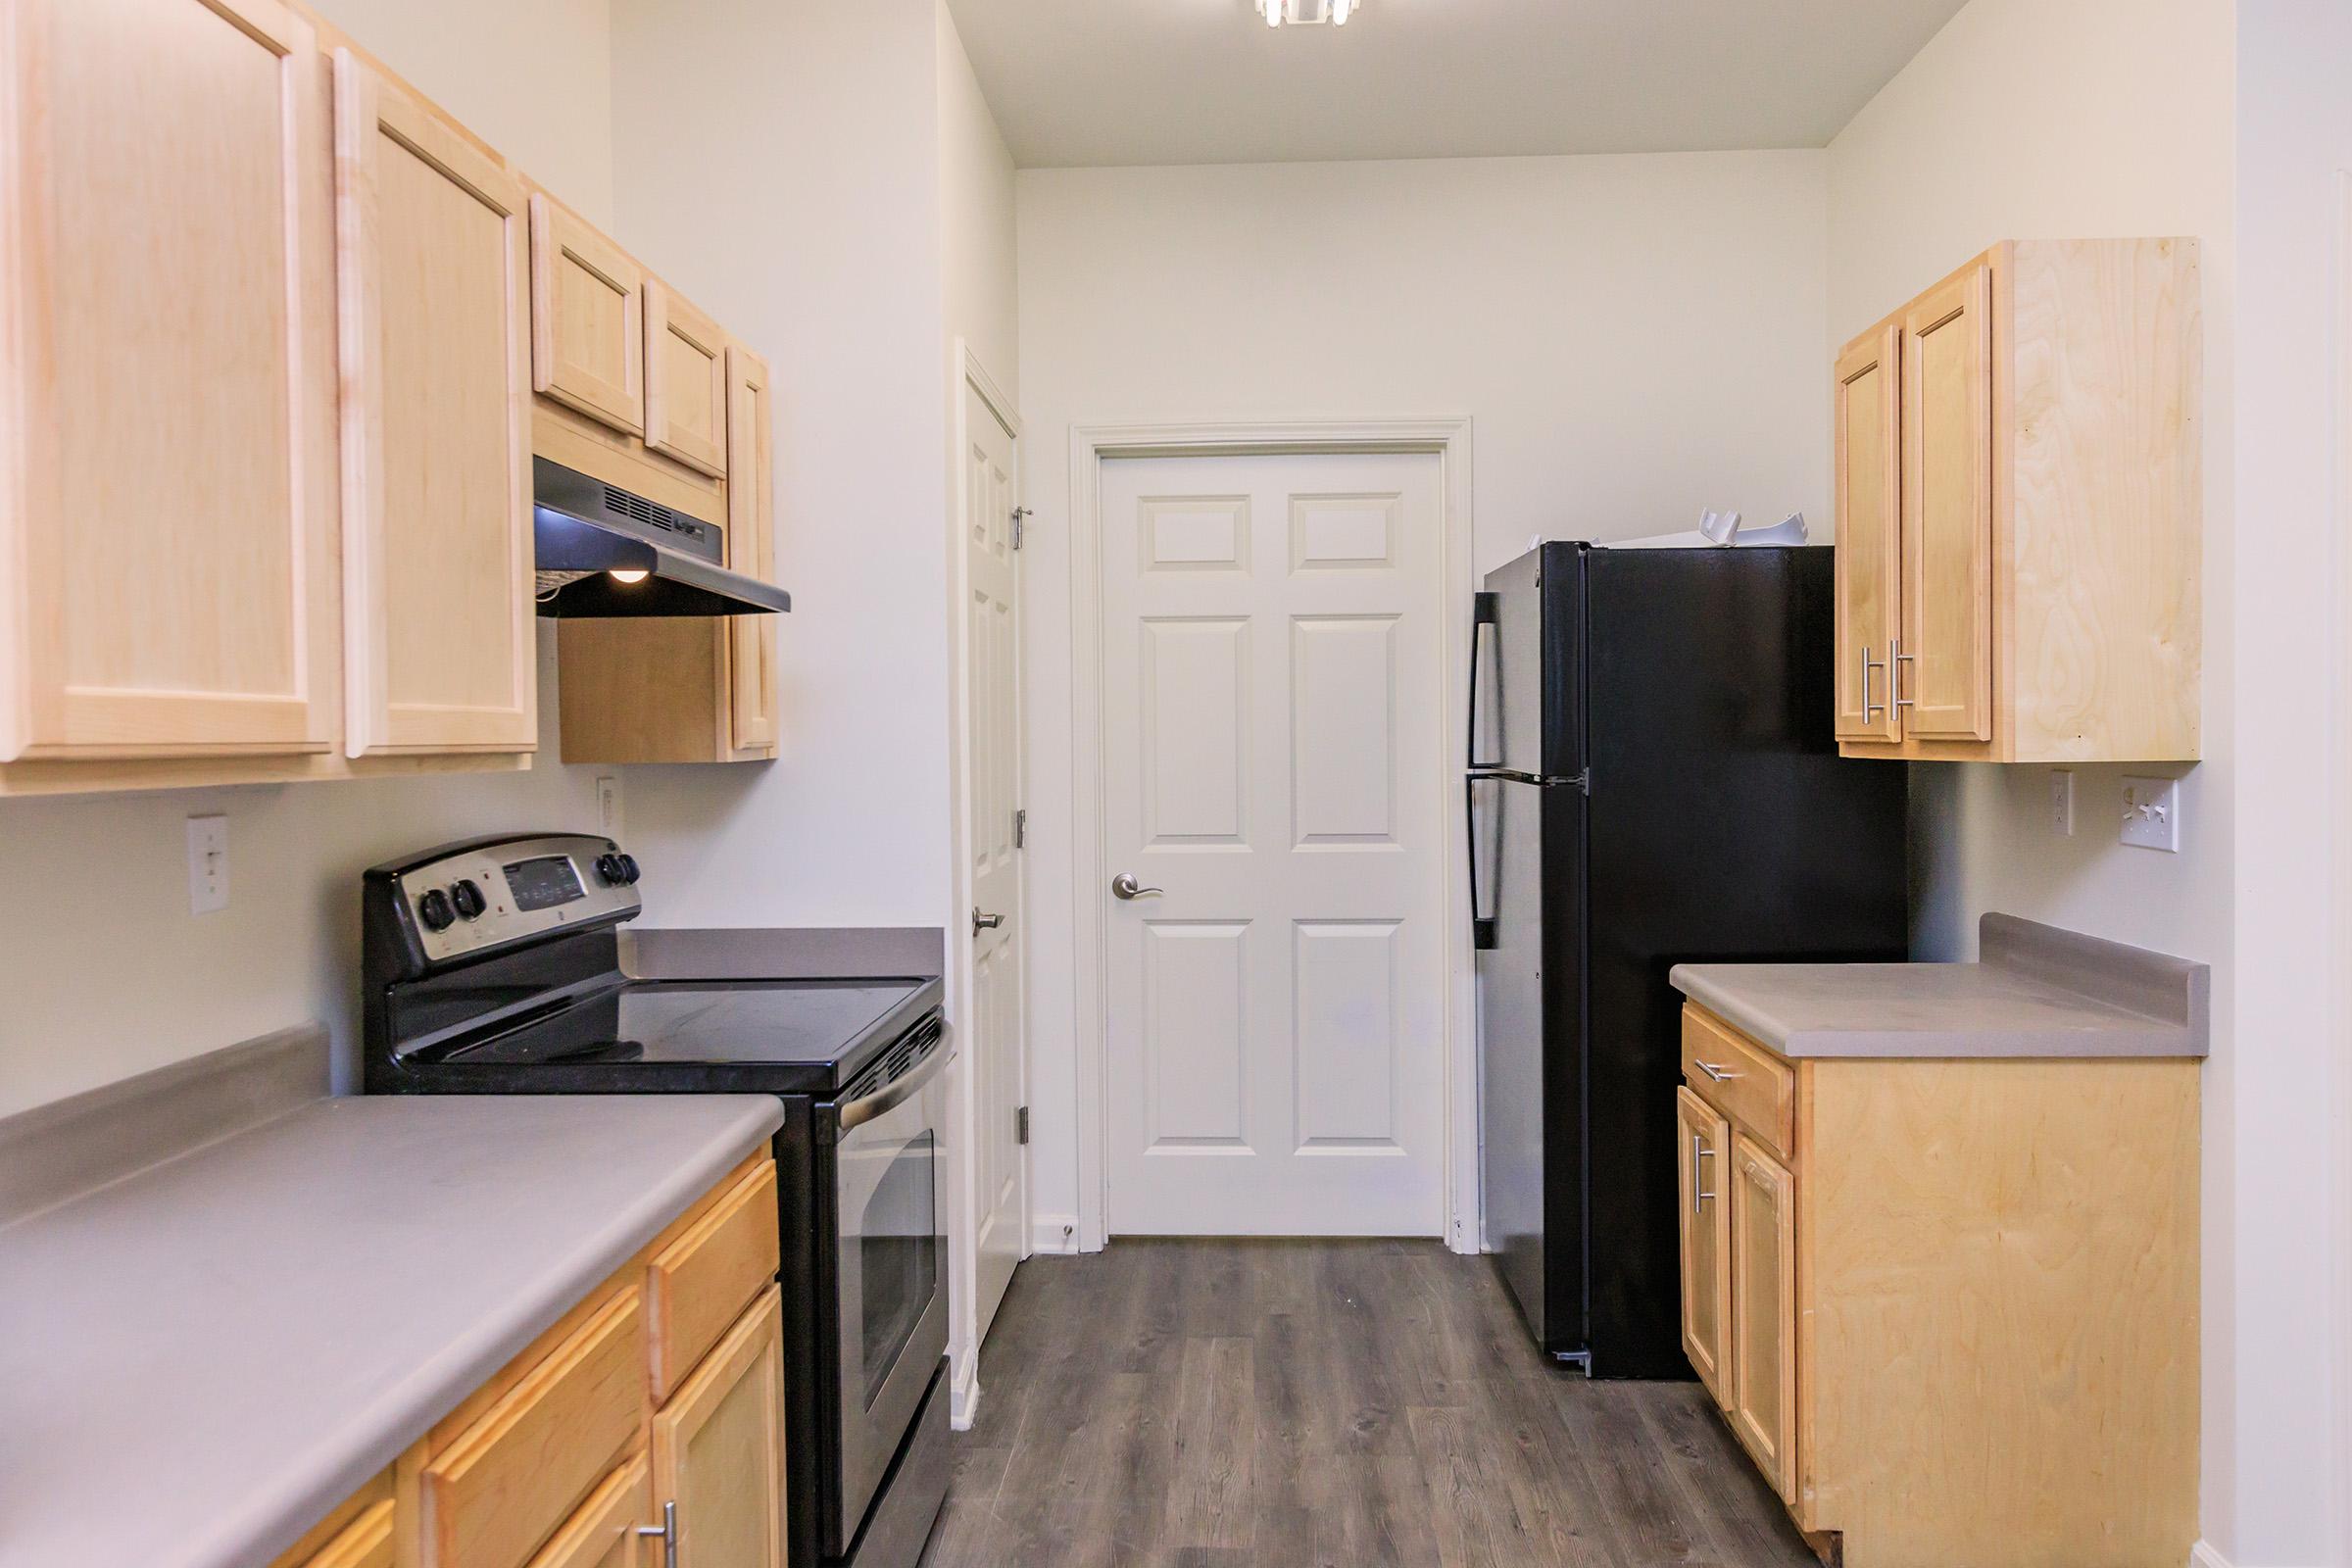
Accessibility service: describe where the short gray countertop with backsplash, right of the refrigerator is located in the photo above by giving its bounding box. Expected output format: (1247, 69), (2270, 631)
(1672, 914), (2209, 1057)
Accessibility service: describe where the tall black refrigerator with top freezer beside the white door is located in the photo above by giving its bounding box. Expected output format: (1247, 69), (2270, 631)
(1468, 543), (1907, 1378)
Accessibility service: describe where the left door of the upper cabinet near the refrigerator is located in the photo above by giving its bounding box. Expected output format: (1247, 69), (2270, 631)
(1835, 322), (1903, 741)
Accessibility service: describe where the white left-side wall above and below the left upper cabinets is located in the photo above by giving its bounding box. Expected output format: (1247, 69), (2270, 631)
(0, 0), (620, 1114)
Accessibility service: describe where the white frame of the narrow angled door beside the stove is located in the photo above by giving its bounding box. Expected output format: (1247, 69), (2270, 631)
(946, 336), (1037, 1432)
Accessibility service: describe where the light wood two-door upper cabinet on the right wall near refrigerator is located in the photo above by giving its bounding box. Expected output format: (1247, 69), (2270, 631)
(1833, 240), (2204, 761)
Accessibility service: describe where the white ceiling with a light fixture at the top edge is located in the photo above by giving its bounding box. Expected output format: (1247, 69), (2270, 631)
(948, 0), (1964, 167)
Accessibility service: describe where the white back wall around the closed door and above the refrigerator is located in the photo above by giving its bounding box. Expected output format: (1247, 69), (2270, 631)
(1018, 153), (1830, 1239)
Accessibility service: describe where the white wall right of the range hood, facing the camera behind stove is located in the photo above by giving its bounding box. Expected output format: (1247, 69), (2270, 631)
(613, 0), (948, 926)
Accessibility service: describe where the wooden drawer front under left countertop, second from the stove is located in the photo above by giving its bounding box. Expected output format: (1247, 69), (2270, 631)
(421, 1286), (645, 1568)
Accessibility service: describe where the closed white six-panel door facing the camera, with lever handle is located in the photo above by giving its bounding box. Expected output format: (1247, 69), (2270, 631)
(1096, 454), (1448, 1237)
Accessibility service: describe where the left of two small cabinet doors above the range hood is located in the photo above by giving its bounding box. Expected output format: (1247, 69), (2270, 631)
(531, 193), (645, 435)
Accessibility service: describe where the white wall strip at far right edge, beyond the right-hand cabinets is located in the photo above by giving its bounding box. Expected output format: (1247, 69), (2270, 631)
(2206, 0), (2352, 1568)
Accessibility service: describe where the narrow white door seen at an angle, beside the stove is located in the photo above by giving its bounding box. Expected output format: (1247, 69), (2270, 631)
(962, 381), (1028, 1345)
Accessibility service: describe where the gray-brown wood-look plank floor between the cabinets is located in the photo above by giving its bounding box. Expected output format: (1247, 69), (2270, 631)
(924, 1242), (1813, 1568)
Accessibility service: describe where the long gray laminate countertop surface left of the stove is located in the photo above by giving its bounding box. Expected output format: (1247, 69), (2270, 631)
(0, 1096), (783, 1568)
